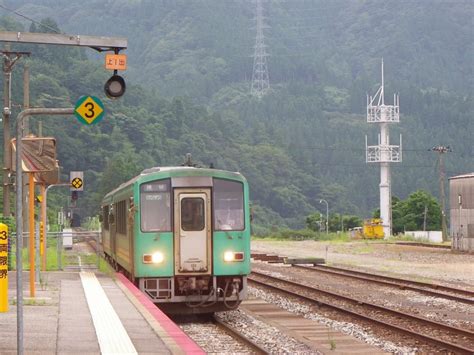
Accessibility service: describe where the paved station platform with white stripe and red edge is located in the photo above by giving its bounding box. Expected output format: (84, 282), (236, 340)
(0, 272), (204, 355)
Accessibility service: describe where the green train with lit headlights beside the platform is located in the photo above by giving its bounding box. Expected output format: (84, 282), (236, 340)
(101, 166), (250, 314)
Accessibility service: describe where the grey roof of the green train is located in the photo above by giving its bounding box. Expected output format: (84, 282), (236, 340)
(104, 166), (246, 199)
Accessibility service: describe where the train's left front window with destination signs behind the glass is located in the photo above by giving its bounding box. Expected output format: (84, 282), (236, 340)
(140, 179), (171, 232)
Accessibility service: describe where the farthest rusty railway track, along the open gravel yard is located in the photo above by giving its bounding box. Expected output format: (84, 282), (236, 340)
(293, 265), (474, 304)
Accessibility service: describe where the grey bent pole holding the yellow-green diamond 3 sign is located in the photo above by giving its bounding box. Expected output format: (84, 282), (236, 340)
(15, 108), (74, 355)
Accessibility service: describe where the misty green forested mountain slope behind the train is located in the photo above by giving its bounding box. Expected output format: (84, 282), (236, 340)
(0, 0), (474, 231)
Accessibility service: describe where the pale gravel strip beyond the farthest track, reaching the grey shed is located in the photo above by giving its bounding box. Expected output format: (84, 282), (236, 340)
(252, 240), (474, 291)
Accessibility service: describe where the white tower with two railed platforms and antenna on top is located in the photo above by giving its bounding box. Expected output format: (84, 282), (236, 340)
(365, 59), (402, 237)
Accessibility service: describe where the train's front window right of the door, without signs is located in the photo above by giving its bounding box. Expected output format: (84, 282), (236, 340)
(213, 179), (244, 230)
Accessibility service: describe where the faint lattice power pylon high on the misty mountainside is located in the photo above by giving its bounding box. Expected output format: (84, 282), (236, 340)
(250, 0), (270, 99)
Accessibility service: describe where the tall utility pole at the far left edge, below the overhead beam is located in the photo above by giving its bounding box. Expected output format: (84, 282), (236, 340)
(0, 44), (30, 217)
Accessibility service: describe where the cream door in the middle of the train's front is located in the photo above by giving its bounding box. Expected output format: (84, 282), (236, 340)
(174, 188), (212, 274)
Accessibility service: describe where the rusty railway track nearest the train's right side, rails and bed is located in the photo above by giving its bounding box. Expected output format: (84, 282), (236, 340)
(248, 272), (474, 354)
